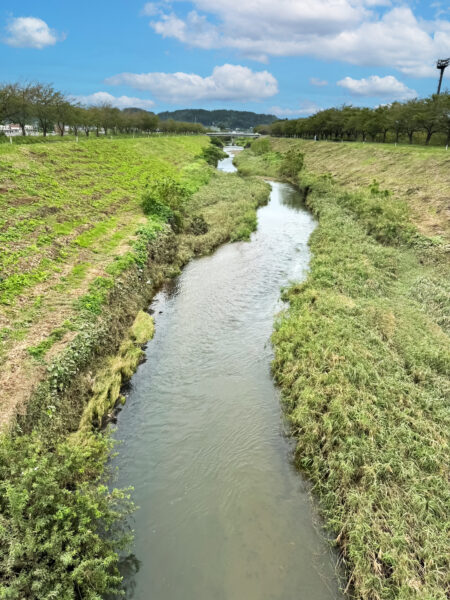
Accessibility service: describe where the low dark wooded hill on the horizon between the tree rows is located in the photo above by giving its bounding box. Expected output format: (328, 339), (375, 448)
(158, 108), (278, 129)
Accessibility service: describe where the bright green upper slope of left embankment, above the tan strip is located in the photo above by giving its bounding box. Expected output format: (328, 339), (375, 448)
(0, 136), (208, 326)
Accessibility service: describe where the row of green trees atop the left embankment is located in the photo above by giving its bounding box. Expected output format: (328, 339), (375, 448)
(0, 83), (205, 136)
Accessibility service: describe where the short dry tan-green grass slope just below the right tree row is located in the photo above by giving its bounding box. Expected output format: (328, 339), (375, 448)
(239, 138), (450, 242)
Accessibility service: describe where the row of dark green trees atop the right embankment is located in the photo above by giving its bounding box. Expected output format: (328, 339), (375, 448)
(255, 92), (450, 145)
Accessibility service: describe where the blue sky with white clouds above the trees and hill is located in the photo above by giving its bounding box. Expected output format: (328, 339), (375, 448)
(0, 0), (450, 118)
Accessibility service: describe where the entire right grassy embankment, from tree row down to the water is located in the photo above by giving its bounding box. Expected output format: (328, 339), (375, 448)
(236, 140), (450, 600)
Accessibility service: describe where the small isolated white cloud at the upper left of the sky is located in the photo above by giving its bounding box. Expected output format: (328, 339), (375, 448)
(4, 17), (65, 50)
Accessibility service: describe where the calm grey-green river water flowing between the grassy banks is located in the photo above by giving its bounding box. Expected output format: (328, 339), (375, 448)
(114, 149), (339, 600)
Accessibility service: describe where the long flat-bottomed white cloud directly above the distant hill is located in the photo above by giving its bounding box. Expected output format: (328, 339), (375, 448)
(106, 64), (278, 104)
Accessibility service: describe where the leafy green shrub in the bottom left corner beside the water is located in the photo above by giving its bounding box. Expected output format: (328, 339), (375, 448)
(0, 435), (132, 600)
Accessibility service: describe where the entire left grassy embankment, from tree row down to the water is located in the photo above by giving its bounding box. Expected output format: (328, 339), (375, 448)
(0, 137), (268, 599)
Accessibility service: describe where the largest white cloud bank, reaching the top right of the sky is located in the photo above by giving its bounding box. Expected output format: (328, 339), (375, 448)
(150, 0), (450, 76)
